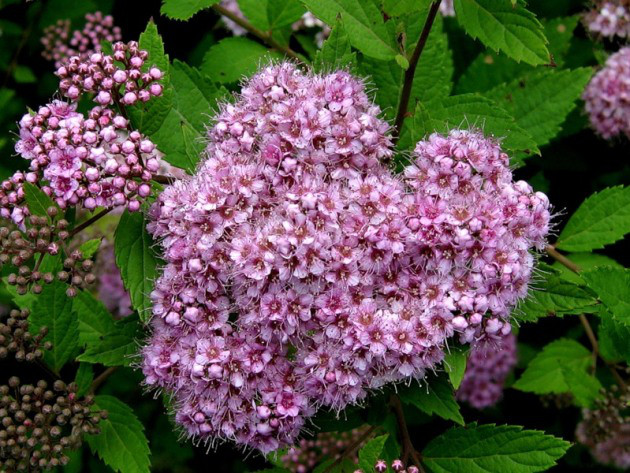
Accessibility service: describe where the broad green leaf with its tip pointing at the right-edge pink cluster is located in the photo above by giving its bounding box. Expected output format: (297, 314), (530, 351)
(484, 67), (593, 147)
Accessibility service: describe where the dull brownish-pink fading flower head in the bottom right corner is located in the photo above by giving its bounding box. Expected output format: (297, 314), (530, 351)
(576, 386), (630, 470)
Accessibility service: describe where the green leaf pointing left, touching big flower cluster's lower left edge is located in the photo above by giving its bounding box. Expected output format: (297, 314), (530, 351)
(77, 316), (141, 366)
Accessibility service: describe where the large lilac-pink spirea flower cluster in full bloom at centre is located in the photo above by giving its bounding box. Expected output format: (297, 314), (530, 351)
(143, 63), (549, 452)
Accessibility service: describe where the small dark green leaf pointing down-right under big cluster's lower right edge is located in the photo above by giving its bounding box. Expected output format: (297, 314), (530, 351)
(399, 376), (464, 425)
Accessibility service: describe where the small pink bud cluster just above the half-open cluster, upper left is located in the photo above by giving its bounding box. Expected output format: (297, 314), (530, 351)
(57, 41), (163, 106)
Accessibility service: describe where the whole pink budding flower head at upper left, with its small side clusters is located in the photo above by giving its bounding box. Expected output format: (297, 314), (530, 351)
(0, 42), (162, 224)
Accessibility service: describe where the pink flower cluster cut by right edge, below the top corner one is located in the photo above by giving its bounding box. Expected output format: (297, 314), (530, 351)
(582, 47), (630, 139)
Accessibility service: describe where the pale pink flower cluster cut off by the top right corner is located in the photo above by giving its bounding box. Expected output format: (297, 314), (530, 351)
(584, 0), (630, 38)
